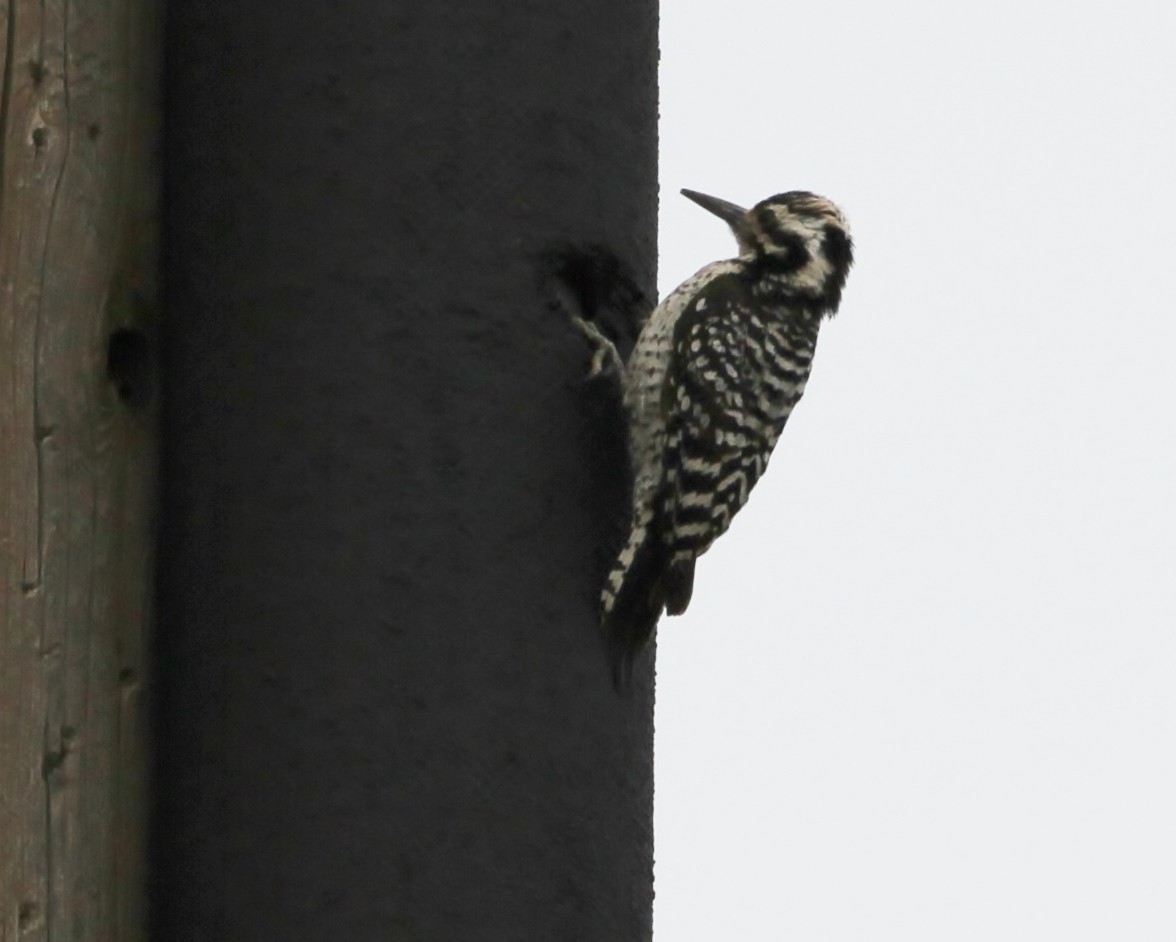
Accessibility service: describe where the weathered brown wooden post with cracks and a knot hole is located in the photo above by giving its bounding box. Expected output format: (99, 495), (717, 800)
(0, 0), (159, 942)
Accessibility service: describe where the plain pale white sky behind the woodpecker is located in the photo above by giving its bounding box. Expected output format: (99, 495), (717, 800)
(655, 0), (1176, 942)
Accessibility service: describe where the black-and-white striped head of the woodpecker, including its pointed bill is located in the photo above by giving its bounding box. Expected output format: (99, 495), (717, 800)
(682, 189), (854, 314)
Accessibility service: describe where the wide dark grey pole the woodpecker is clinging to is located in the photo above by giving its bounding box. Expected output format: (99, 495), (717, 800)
(153, 0), (656, 942)
